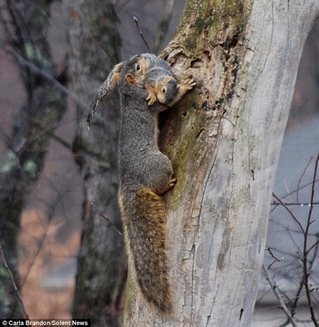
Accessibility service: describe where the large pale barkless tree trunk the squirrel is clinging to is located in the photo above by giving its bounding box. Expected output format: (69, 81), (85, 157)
(125, 0), (319, 327)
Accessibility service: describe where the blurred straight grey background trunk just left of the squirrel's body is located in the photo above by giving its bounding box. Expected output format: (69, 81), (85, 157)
(64, 0), (126, 326)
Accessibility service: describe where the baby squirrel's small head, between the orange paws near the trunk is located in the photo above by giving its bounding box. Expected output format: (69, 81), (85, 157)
(154, 75), (180, 104)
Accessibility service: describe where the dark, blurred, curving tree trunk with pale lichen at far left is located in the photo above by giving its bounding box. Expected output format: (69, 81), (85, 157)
(0, 0), (66, 319)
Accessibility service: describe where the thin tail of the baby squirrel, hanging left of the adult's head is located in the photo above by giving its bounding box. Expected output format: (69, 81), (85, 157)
(86, 62), (125, 127)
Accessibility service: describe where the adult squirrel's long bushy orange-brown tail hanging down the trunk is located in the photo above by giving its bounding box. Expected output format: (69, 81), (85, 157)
(120, 188), (174, 315)
